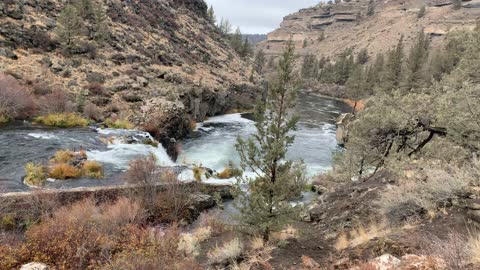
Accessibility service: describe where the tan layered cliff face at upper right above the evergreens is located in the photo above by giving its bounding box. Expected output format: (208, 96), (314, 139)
(258, 0), (480, 58)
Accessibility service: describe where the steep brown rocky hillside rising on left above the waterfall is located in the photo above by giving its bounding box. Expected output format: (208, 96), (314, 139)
(0, 0), (255, 142)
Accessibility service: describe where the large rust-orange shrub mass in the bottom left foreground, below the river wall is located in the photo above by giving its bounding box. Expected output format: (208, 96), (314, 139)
(21, 198), (147, 269)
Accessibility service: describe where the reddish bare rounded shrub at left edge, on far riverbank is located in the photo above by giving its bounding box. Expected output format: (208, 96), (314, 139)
(0, 73), (35, 122)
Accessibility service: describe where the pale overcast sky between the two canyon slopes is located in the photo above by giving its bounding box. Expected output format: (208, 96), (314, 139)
(205, 0), (320, 34)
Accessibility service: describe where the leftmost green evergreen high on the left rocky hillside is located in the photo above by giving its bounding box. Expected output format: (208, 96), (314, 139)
(55, 4), (84, 46)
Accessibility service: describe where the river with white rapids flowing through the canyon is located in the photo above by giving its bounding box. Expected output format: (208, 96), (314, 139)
(0, 93), (350, 192)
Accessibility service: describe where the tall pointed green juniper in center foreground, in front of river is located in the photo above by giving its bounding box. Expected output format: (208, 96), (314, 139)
(235, 41), (305, 241)
